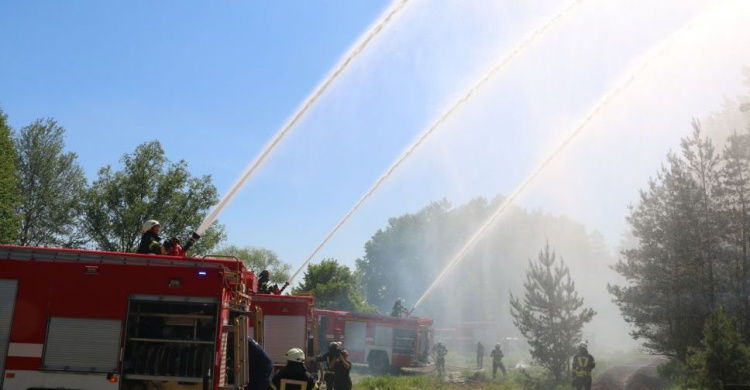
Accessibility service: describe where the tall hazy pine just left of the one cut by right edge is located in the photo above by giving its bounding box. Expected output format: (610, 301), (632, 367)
(608, 121), (736, 362)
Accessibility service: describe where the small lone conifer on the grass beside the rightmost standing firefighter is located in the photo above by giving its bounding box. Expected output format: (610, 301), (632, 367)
(510, 244), (596, 383)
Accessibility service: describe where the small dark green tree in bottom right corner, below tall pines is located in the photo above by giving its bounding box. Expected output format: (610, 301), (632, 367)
(686, 307), (750, 390)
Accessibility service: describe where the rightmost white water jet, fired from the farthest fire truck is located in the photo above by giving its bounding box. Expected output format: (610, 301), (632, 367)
(412, 0), (728, 310)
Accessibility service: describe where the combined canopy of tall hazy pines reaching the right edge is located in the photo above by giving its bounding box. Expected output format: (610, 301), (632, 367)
(609, 121), (750, 362)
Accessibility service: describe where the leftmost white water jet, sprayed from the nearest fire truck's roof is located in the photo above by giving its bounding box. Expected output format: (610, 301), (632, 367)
(196, 0), (409, 235)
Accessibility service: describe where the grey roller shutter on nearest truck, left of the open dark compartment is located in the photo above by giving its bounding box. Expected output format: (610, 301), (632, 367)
(43, 317), (122, 372)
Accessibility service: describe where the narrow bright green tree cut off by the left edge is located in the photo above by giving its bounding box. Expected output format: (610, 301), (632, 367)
(0, 109), (21, 244)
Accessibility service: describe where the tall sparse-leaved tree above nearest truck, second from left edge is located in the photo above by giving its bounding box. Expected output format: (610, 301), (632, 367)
(16, 119), (86, 247)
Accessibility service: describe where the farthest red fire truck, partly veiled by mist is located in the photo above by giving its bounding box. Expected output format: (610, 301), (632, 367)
(314, 309), (432, 372)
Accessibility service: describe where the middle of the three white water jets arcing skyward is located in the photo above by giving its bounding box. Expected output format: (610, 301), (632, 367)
(287, 0), (583, 284)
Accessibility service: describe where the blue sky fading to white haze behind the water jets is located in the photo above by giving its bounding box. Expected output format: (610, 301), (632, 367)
(0, 0), (750, 278)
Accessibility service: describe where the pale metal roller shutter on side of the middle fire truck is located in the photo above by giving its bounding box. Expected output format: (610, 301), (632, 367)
(263, 315), (307, 364)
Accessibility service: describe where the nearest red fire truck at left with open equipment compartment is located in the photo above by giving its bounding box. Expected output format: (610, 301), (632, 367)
(0, 245), (262, 390)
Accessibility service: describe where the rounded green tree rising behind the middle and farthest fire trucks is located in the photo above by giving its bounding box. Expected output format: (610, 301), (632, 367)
(293, 259), (377, 313)
